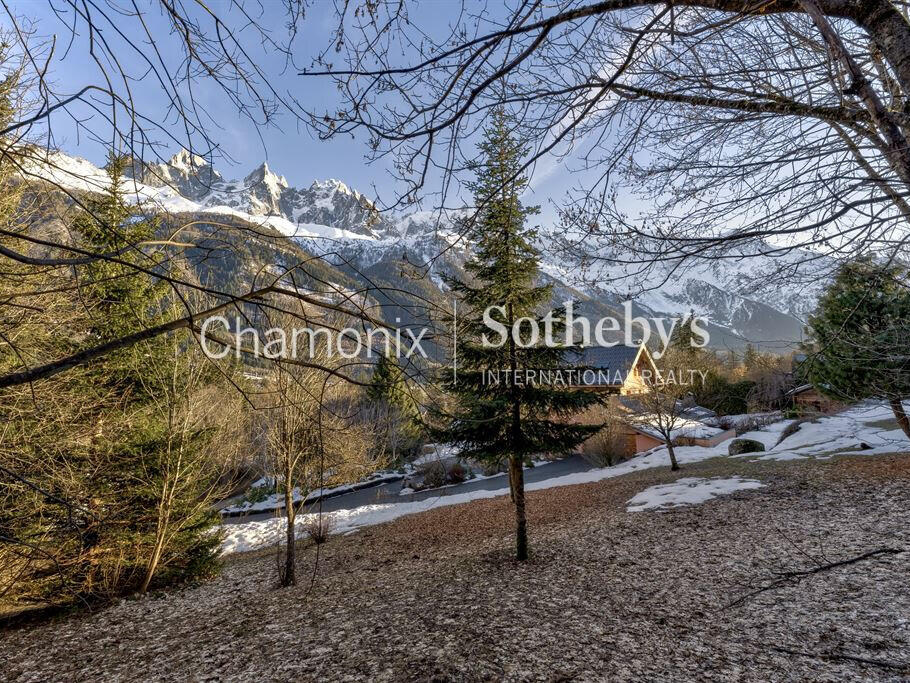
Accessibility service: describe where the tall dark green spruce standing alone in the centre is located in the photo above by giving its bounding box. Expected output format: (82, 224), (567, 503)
(440, 110), (600, 560)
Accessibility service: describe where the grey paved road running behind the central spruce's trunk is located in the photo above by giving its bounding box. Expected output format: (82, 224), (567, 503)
(224, 455), (591, 524)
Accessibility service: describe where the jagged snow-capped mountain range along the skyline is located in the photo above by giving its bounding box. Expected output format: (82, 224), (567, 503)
(26, 150), (830, 348)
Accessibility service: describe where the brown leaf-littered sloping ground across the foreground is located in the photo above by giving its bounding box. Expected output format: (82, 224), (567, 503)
(0, 454), (910, 681)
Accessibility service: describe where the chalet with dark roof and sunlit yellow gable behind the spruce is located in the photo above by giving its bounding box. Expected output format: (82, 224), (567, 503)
(568, 344), (659, 396)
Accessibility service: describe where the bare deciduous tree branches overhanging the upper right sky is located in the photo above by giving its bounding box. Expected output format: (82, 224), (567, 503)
(305, 0), (910, 289)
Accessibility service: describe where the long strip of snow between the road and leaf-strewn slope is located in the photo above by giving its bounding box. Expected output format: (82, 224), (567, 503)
(222, 401), (910, 553)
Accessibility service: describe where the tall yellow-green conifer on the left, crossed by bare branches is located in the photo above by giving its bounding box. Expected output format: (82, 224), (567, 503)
(72, 155), (218, 591)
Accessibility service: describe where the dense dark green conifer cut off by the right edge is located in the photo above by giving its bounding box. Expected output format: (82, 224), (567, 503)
(802, 258), (910, 437)
